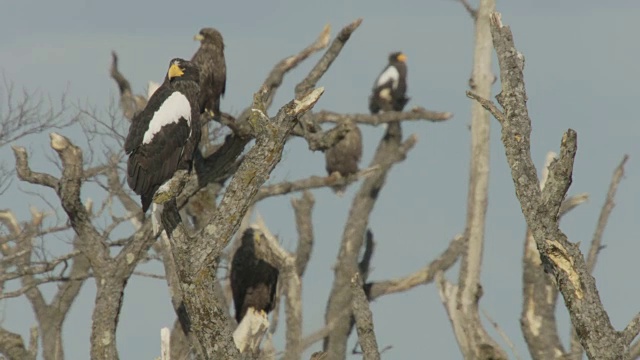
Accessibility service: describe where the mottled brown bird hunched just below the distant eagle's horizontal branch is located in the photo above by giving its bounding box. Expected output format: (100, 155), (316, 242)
(324, 121), (362, 195)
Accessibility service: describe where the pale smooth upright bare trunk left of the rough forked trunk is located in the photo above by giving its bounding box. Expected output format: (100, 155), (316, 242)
(439, 0), (507, 359)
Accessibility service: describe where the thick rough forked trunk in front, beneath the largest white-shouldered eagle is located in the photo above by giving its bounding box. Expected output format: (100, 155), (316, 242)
(162, 88), (324, 359)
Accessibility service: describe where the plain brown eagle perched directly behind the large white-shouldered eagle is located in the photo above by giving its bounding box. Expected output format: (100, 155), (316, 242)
(191, 28), (227, 116)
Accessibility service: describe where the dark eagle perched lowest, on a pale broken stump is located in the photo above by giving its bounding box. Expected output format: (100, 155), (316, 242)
(229, 228), (279, 324)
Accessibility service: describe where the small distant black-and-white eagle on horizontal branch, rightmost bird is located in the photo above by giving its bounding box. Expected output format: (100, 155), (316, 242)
(369, 52), (409, 114)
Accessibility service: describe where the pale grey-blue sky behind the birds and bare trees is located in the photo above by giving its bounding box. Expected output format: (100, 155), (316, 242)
(0, 0), (640, 359)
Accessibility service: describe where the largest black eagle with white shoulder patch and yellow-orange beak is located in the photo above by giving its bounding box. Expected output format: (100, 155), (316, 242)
(124, 58), (201, 212)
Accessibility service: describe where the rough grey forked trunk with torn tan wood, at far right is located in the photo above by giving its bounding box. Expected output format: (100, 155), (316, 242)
(482, 13), (629, 359)
